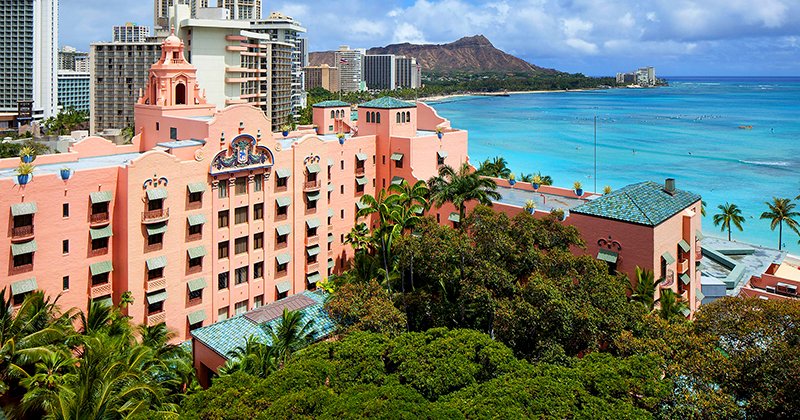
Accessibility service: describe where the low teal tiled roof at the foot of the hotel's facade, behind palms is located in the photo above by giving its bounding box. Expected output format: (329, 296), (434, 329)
(191, 292), (336, 358)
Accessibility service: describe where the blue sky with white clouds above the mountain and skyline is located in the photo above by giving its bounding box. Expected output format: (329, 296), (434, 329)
(60, 0), (800, 76)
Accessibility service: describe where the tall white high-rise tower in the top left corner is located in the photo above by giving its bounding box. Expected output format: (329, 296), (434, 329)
(0, 0), (58, 125)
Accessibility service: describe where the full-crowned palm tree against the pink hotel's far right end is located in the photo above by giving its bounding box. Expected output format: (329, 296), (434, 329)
(428, 163), (501, 226)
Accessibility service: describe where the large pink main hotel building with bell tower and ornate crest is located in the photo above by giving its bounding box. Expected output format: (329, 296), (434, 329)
(0, 36), (468, 344)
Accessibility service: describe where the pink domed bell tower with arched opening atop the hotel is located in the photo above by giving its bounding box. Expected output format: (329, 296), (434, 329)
(137, 28), (206, 108)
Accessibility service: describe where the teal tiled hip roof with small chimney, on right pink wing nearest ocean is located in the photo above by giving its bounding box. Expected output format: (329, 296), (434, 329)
(570, 181), (700, 226)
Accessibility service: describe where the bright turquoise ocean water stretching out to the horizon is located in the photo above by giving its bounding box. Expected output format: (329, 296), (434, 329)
(433, 77), (800, 254)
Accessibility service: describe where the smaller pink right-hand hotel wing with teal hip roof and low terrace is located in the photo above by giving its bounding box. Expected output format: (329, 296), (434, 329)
(495, 179), (704, 316)
